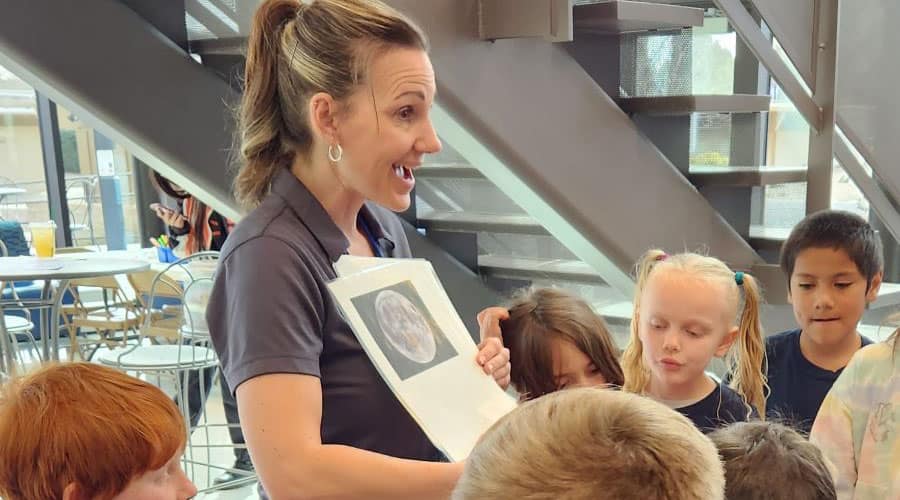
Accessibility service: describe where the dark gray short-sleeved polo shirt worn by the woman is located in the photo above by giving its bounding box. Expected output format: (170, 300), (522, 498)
(207, 169), (439, 460)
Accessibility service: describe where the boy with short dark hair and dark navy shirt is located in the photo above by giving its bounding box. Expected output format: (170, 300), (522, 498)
(766, 210), (884, 433)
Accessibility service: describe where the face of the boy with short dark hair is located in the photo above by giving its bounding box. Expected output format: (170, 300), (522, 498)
(788, 248), (881, 343)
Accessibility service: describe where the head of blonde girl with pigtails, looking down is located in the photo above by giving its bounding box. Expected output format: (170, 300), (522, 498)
(622, 250), (765, 415)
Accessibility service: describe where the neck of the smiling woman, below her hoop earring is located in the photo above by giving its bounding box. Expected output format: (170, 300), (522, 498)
(291, 156), (365, 241)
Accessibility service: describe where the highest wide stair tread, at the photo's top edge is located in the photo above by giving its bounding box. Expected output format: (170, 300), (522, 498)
(572, 1), (703, 35)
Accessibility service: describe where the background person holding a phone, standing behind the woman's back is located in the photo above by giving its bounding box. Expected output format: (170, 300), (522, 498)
(150, 172), (253, 489)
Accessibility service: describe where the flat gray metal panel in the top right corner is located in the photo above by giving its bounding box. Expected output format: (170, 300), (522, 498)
(836, 0), (900, 212)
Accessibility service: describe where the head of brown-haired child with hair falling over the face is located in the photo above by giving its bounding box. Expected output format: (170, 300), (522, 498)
(500, 288), (624, 400)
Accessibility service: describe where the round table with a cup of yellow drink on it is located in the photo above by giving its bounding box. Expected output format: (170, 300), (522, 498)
(0, 254), (150, 374)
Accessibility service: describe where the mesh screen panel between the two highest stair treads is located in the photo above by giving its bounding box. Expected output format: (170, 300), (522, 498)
(619, 30), (693, 97)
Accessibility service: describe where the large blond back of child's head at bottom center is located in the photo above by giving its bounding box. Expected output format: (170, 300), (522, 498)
(453, 387), (725, 500)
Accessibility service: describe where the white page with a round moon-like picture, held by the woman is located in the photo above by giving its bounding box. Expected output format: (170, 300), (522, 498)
(328, 259), (516, 461)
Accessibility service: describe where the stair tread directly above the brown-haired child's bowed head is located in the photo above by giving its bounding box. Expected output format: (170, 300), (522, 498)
(478, 255), (605, 284)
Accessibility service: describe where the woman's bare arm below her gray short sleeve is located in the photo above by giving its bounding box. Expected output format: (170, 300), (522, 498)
(237, 374), (463, 500)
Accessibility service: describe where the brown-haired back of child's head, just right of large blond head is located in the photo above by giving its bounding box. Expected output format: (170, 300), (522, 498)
(709, 421), (837, 500)
